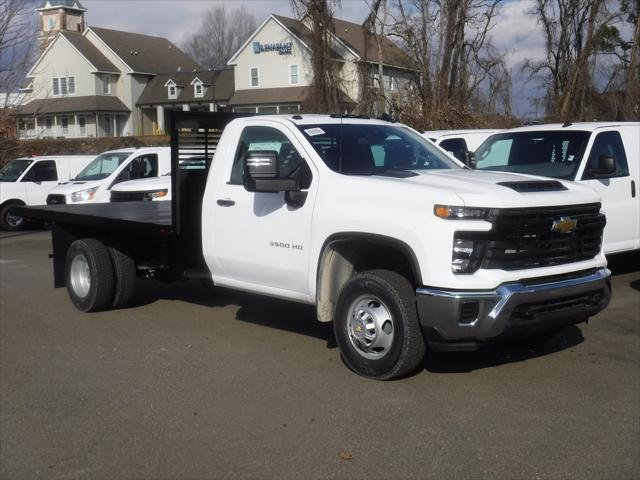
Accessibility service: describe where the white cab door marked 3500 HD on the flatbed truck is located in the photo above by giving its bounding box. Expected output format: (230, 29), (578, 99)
(210, 121), (317, 296)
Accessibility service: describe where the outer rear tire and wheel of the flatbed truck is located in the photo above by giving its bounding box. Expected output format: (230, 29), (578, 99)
(65, 238), (114, 312)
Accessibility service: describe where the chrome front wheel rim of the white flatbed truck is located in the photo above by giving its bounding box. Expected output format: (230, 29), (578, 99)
(347, 295), (395, 360)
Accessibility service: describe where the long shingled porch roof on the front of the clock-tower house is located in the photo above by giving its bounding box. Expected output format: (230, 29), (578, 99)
(18, 95), (131, 115)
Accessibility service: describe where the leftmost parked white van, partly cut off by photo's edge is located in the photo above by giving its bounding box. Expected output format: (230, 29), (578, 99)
(0, 155), (95, 230)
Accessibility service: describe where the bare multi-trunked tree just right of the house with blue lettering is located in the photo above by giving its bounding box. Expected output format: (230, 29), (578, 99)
(390, 0), (511, 128)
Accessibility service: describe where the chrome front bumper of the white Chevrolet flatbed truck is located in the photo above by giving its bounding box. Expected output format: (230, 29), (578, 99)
(416, 268), (611, 350)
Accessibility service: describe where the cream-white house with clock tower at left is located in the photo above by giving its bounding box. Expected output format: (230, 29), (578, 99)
(18, 0), (231, 138)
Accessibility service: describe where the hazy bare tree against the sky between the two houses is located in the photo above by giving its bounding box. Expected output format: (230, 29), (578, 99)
(184, 4), (256, 70)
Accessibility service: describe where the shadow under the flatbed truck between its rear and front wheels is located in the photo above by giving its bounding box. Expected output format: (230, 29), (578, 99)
(131, 280), (337, 348)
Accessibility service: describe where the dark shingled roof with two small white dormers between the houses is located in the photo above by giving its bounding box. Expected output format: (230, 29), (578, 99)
(137, 69), (235, 105)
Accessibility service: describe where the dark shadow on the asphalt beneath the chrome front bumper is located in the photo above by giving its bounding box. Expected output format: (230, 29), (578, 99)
(424, 325), (584, 373)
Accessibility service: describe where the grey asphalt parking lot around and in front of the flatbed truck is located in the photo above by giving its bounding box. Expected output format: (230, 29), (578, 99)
(0, 231), (640, 479)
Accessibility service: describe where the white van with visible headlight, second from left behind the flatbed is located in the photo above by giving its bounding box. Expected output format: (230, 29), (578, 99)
(47, 147), (171, 205)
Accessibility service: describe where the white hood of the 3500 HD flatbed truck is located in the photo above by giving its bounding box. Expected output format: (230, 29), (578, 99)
(393, 170), (601, 208)
